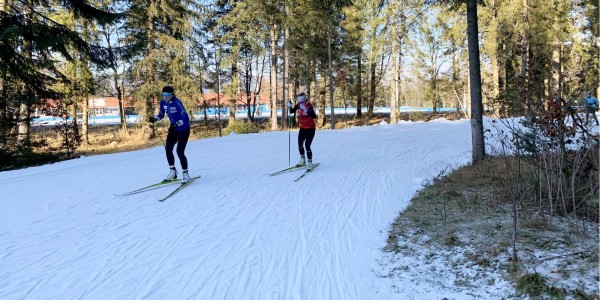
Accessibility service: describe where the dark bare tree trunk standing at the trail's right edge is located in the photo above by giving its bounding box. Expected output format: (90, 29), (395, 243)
(467, 0), (485, 164)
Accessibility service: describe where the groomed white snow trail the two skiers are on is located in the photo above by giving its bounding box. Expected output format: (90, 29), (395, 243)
(0, 121), (470, 299)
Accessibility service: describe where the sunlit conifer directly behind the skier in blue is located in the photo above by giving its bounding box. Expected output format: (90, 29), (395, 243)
(125, 0), (199, 138)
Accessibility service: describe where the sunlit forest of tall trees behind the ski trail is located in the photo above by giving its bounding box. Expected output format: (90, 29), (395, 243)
(0, 0), (600, 169)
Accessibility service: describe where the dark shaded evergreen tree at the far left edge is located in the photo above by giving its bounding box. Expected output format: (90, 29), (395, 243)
(0, 0), (121, 150)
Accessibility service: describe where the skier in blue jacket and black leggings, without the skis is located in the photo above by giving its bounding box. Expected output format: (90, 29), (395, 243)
(149, 86), (190, 182)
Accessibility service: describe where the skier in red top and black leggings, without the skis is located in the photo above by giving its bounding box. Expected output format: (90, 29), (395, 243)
(288, 93), (317, 170)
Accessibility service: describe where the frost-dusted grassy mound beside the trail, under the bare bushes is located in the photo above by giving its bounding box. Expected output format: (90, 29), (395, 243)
(384, 157), (598, 299)
